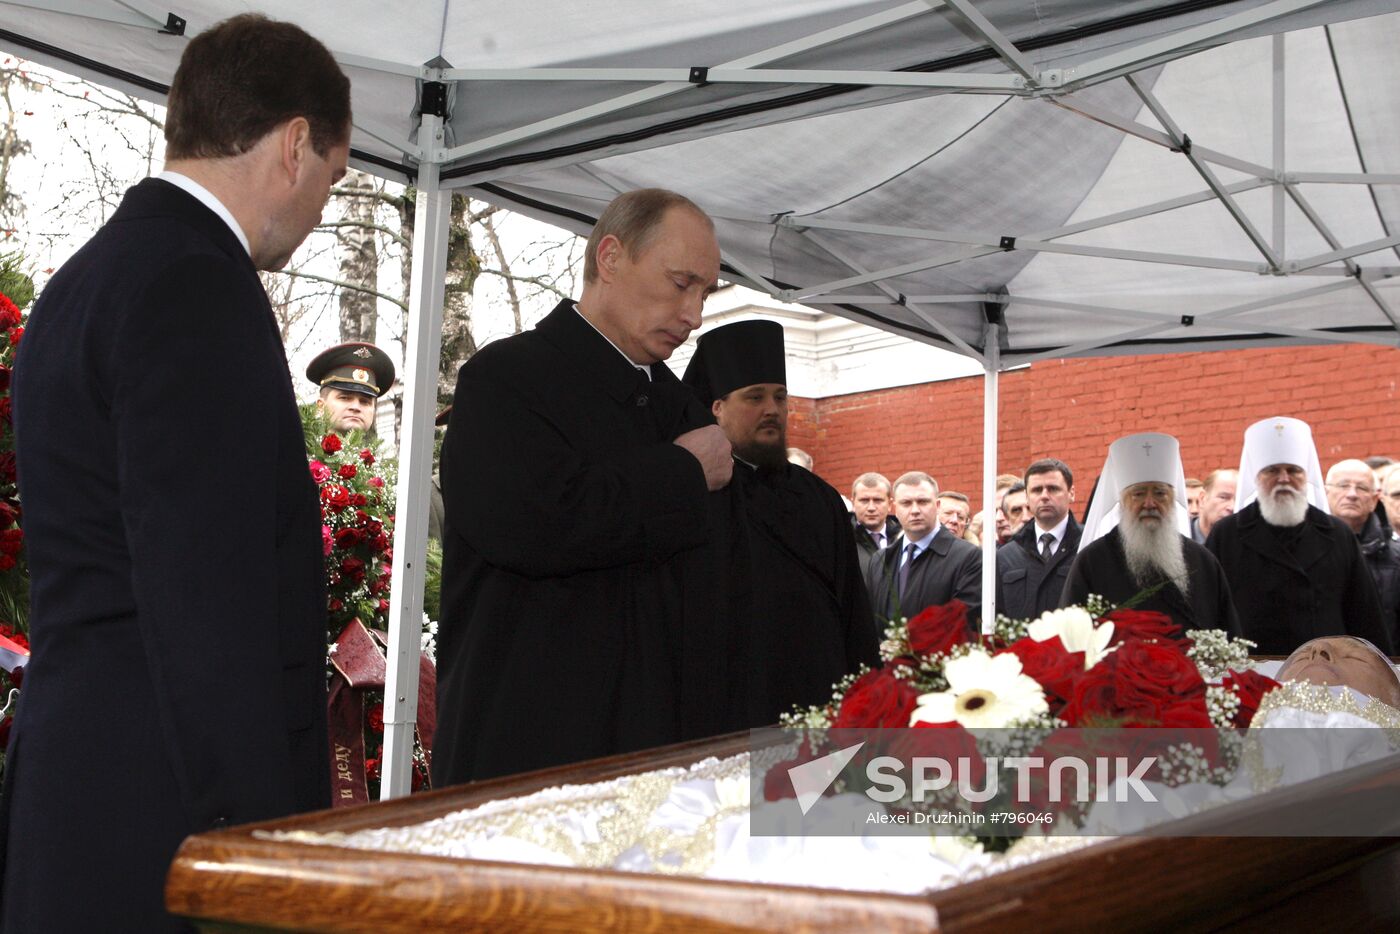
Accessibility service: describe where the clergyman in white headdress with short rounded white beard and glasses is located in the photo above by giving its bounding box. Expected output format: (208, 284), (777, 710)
(1205, 417), (1390, 655)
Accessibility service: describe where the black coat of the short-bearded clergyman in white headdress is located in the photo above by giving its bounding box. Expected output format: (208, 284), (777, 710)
(1205, 503), (1392, 655)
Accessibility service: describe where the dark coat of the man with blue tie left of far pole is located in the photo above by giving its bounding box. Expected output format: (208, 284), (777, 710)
(865, 525), (981, 625)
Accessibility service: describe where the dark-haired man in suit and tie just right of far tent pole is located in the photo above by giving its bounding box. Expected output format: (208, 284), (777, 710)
(997, 458), (1082, 619)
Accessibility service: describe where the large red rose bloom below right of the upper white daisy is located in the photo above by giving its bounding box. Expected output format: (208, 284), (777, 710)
(1061, 639), (1210, 727)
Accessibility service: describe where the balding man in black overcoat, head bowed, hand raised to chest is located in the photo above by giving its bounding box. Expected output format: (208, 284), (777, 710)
(433, 189), (734, 787)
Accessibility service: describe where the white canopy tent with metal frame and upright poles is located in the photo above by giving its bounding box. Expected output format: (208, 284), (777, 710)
(0, 0), (1400, 795)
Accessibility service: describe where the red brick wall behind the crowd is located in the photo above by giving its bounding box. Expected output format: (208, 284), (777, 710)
(788, 344), (1400, 517)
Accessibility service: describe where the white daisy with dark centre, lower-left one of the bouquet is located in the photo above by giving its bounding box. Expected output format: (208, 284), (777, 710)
(909, 648), (1049, 728)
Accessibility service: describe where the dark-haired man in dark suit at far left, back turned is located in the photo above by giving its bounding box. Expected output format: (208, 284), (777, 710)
(3, 15), (350, 931)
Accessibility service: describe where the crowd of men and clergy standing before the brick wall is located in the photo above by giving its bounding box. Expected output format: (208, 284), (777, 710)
(851, 417), (1400, 655)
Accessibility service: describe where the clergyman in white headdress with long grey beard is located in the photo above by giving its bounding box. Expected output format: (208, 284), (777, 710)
(1060, 433), (1239, 634)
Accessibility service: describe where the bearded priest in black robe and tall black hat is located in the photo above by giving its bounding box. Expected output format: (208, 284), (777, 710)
(683, 321), (879, 727)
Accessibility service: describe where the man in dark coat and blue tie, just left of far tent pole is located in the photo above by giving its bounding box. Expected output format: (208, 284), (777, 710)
(865, 471), (981, 625)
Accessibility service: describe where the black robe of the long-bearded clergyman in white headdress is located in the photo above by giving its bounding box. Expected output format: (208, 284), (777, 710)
(1060, 527), (1239, 636)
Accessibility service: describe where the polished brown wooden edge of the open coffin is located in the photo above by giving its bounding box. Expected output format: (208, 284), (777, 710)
(167, 734), (1400, 934)
